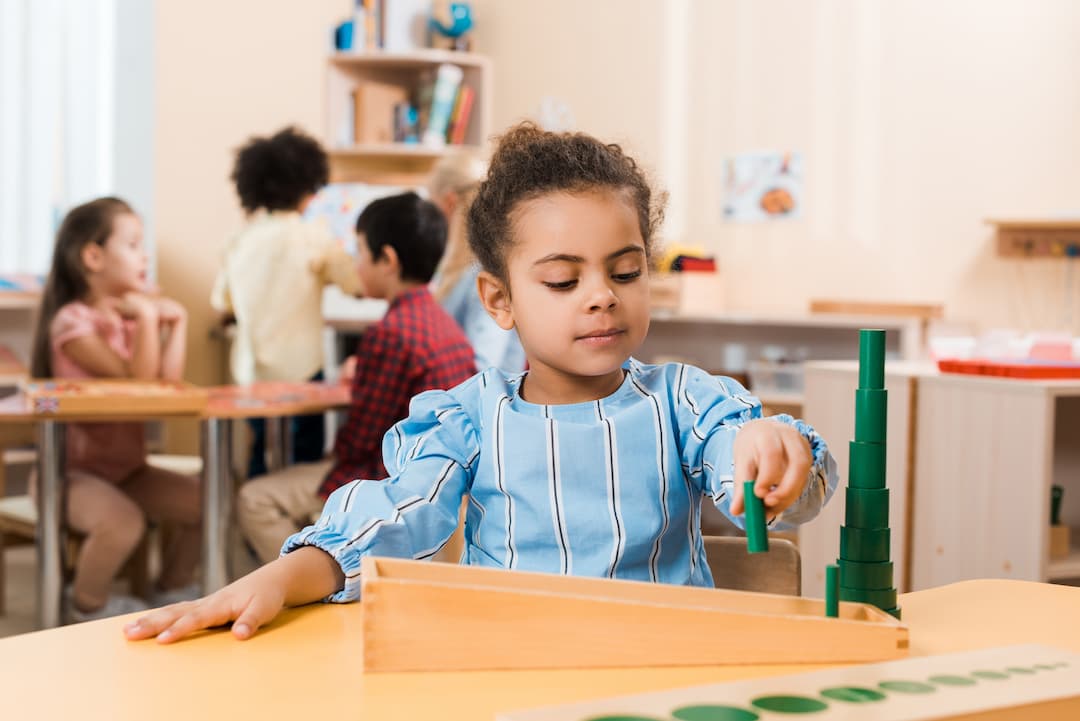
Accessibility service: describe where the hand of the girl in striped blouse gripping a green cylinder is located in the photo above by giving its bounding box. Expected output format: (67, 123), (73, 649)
(731, 419), (813, 517)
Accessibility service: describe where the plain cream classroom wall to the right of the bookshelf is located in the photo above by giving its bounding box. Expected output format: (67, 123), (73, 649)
(474, 0), (1080, 334)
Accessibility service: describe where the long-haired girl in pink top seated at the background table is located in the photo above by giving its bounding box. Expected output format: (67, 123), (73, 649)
(31, 198), (200, 621)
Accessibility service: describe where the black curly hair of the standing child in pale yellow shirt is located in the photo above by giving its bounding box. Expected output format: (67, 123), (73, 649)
(231, 126), (329, 213)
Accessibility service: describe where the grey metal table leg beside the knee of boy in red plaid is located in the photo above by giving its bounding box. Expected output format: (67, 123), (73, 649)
(202, 418), (233, 595)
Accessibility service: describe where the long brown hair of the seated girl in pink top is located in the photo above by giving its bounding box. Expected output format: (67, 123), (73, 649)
(30, 198), (135, 378)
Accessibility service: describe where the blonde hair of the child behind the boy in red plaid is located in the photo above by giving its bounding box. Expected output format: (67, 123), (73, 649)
(428, 151), (487, 300)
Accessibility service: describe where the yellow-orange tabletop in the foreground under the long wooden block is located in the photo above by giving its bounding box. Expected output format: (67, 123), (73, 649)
(0, 581), (1080, 721)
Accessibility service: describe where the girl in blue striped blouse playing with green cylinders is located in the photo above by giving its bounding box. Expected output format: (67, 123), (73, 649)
(125, 124), (837, 642)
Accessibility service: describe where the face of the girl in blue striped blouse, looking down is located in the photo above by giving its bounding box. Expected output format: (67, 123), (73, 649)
(481, 191), (649, 403)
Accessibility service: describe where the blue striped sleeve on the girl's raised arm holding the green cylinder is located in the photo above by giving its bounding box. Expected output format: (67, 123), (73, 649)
(674, 366), (839, 530)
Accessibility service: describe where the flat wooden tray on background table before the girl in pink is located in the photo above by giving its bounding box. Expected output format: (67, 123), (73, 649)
(23, 379), (206, 416)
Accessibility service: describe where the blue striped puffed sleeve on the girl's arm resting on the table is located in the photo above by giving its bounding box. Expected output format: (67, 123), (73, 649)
(282, 379), (480, 602)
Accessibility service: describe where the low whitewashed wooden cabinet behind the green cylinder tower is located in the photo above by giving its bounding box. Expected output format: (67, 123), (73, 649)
(799, 363), (1080, 596)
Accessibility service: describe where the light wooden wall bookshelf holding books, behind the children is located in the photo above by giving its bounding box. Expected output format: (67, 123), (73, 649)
(326, 49), (491, 185)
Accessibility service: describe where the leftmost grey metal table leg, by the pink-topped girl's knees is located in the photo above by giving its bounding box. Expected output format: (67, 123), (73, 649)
(37, 421), (65, 628)
